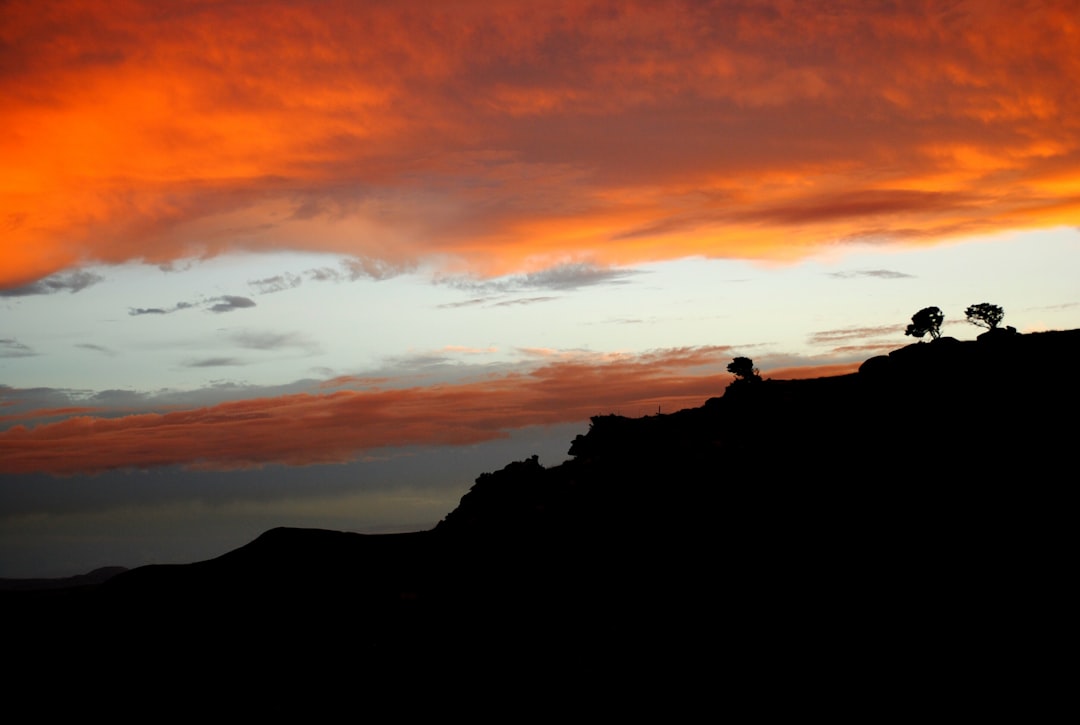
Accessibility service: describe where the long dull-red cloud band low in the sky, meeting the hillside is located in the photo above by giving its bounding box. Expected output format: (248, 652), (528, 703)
(0, 347), (751, 474)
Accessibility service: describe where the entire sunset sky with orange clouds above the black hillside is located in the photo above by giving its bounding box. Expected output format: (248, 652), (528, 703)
(0, 0), (1080, 577)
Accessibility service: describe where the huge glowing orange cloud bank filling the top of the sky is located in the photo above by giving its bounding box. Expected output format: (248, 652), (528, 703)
(0, 0), (1080, 287)
